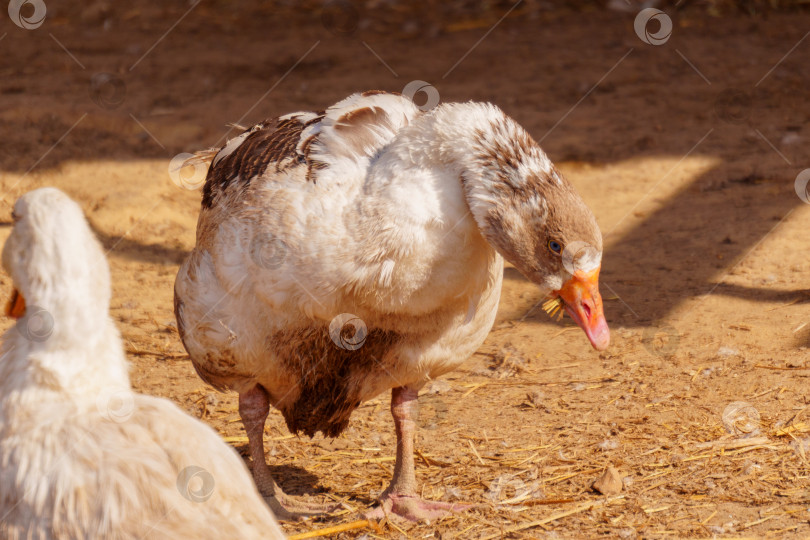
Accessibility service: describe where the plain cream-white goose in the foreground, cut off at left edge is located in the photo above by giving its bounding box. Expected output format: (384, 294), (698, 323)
(0, 188), (284, 540)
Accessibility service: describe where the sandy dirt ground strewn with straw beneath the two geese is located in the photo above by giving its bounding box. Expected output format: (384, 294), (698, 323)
(0, 0), (810, 539)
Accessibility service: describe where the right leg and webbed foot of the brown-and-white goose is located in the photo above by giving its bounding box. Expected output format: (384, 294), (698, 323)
(367, 387), (470, 521)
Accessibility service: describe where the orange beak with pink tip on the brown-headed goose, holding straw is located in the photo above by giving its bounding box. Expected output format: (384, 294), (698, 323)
(552, 268), (610, 351)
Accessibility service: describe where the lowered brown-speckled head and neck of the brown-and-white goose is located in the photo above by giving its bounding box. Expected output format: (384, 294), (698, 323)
(437, 103), (610, 350)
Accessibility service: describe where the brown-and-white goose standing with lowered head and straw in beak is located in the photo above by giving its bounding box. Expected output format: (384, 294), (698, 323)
(175, 91), (609, 519)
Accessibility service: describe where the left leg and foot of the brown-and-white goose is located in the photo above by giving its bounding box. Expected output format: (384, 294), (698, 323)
(239, 384), (337, 521)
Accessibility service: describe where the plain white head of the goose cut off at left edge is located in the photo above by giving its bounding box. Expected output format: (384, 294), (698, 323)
(2, 188), (112, 350)
